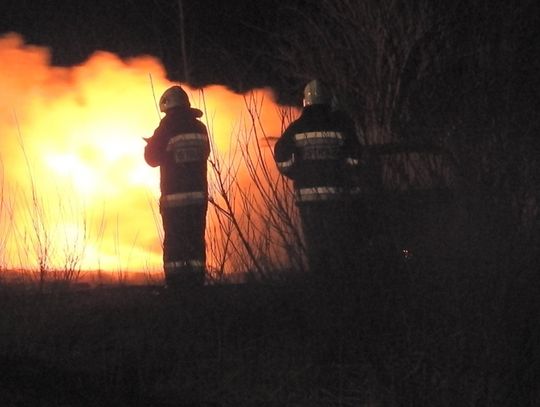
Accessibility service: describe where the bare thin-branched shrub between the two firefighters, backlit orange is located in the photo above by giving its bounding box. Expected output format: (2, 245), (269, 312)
(204, 93), (304, 279)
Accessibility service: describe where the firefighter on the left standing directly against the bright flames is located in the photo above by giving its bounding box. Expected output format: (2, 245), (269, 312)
(144, 86), (210, 287)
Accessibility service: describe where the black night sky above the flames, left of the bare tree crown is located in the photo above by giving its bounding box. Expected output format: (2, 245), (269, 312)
(0, 0), (286, 94)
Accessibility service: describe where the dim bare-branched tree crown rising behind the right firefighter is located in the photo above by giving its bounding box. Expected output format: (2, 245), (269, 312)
(277, 0), (443, 144)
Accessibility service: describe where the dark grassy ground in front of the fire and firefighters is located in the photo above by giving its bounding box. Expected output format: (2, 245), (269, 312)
(0, 265), (540, 407)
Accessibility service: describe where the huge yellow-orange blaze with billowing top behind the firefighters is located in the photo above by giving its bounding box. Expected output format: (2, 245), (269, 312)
(0, 34), (292, 280)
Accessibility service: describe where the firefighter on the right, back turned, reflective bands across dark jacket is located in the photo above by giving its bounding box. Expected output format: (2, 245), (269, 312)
(274, 80), (361, 275)
